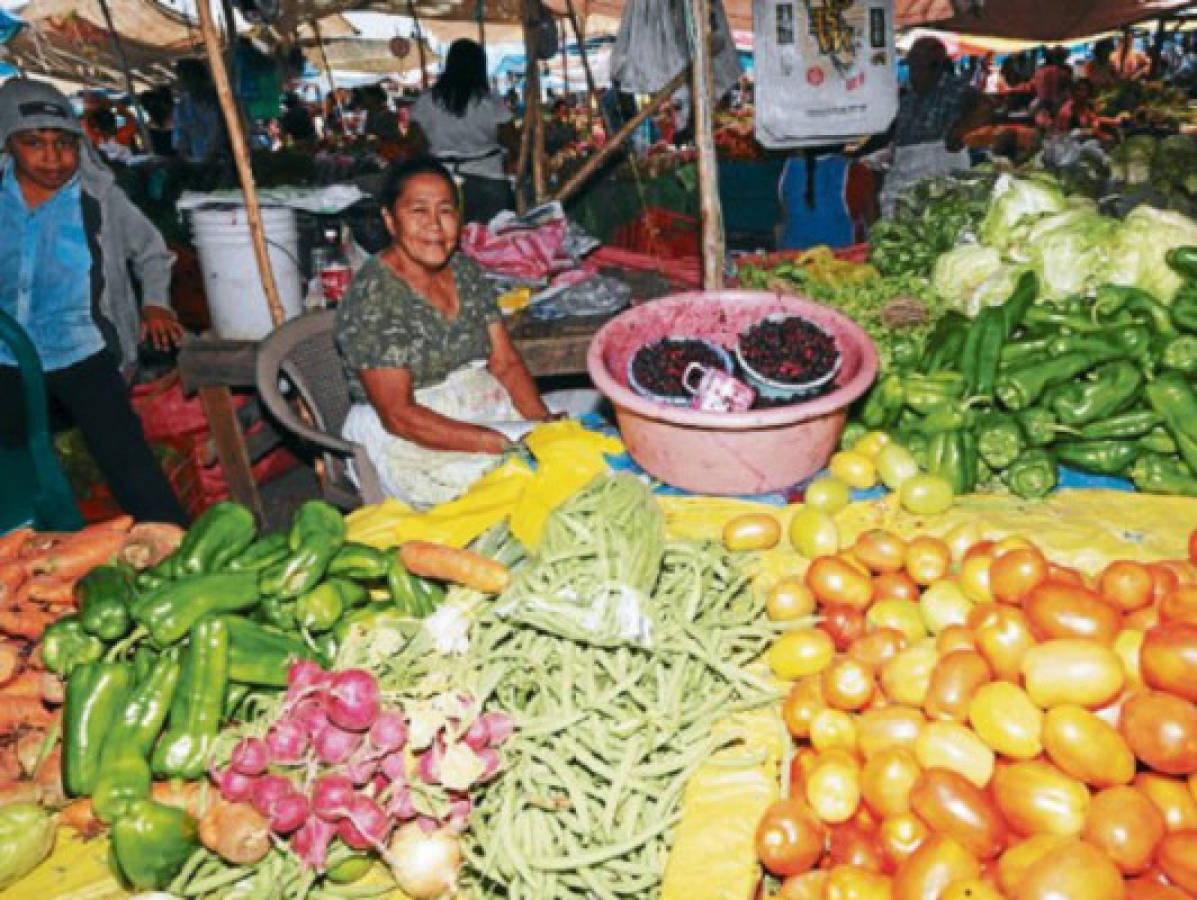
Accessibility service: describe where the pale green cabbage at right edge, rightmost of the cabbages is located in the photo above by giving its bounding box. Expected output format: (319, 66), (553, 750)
(1105, 206), (1197, 303)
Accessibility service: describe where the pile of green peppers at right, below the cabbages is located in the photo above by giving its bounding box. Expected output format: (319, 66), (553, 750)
(856, 247), (1197, 498)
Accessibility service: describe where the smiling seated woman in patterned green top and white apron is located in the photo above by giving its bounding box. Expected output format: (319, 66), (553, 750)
(336, 157), (549, 505)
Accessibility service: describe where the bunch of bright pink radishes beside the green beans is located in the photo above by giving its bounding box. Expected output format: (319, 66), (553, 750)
(212, 661), (512, 870)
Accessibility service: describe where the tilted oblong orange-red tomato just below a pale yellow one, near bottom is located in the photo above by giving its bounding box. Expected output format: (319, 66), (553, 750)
(910, 768), (1009, 859)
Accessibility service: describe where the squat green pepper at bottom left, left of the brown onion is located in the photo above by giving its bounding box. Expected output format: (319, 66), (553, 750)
(111, 799), (200, 890)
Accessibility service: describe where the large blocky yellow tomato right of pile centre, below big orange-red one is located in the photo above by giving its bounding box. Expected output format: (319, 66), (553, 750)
(1021, 638), (1126, 710)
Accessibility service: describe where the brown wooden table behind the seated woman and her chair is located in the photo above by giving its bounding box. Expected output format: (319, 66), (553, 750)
(178, 315), (607, 522)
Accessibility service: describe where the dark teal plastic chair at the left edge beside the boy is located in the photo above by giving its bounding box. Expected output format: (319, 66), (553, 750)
(0, 311), (83, 534)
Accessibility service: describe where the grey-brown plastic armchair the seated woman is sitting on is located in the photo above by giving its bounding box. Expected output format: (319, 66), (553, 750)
(256, 310), (383, 510)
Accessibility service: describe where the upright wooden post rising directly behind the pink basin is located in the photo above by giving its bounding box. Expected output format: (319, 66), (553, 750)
(687, 0), (724, 291)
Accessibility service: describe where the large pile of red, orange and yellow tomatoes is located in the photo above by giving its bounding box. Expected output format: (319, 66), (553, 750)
(757, 528), (1197, 900)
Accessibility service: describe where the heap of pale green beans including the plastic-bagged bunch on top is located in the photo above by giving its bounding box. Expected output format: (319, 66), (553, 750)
(466, 476), (777, 900)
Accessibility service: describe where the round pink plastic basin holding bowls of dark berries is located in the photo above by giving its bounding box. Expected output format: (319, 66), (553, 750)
(587, 291), (877, 494)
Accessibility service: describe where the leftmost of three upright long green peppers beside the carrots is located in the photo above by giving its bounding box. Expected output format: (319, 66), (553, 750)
(62, 662), (133, 797)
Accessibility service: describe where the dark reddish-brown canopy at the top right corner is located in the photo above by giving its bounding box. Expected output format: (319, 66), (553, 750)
(895, 0), (1197, 43)
